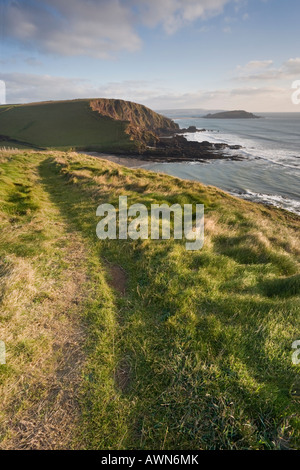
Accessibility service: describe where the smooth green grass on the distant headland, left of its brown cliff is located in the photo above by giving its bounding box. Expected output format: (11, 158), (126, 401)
(0, 100), (136, 151)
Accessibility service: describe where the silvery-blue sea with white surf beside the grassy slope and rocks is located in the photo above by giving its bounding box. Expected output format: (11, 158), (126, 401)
(143, 110), (300, 215)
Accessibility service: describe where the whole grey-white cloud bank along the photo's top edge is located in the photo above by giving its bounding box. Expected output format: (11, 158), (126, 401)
(3, 0), (241, 59)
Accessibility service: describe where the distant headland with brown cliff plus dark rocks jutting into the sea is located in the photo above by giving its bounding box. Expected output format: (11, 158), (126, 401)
(0, 98), (244, 162)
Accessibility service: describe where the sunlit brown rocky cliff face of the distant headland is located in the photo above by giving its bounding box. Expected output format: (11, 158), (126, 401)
(90, 98), (179, 145)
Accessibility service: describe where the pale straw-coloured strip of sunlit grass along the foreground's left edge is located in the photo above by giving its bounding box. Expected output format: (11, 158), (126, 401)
(0, 154), (91, 449)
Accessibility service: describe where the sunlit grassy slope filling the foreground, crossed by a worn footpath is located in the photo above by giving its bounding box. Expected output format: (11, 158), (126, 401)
(0, 152), (300, 449)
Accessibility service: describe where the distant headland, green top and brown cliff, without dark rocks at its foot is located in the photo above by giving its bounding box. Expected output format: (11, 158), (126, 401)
(0, 99), (176, 152)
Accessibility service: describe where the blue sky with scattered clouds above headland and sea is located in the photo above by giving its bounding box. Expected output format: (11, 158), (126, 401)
(0, 0), (300, 112)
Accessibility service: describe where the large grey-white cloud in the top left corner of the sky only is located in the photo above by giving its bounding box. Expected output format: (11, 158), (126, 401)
(5, 0), (141, 58)
